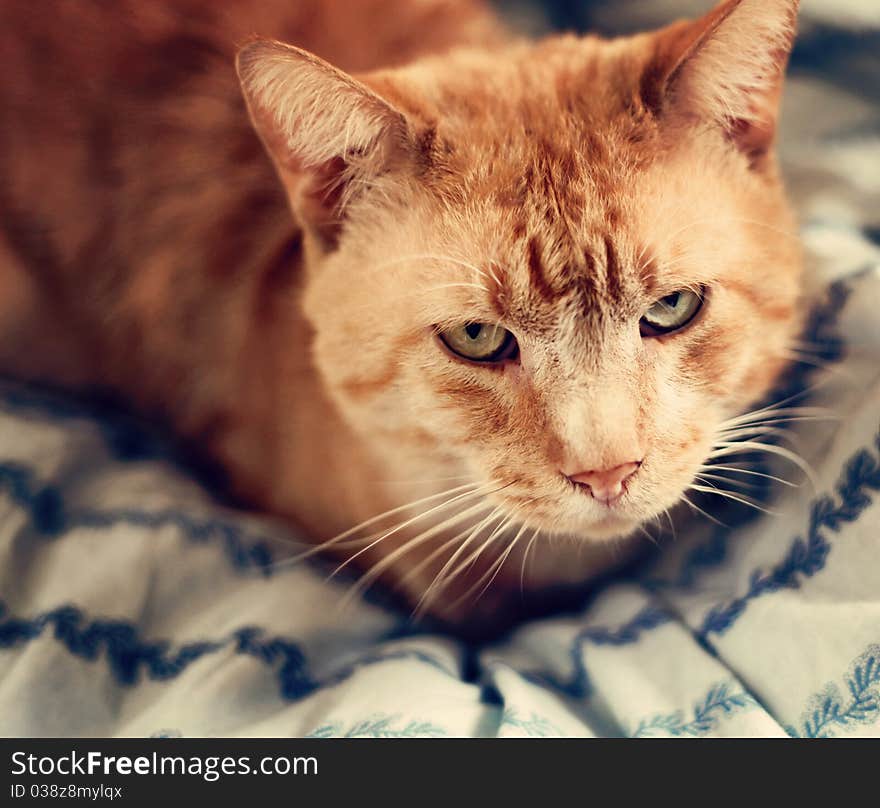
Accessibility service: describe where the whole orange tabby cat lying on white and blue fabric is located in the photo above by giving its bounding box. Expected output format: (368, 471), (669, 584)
(0, 0), (801, 621)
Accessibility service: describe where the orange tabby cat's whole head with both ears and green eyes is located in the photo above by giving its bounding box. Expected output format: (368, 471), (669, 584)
(239, 0), (801, 539)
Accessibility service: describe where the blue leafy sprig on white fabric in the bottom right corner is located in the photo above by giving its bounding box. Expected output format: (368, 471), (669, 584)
(788, 645), (880, 738)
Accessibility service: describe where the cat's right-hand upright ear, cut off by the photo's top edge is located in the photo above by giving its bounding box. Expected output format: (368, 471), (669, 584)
(655, 0), (798, 166)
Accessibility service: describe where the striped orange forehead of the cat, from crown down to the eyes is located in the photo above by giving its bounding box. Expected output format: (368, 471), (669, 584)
(358, 37), (736, 324)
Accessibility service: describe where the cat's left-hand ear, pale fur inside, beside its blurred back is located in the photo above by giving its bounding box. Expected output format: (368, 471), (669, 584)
(237, 41), (409, 248)
